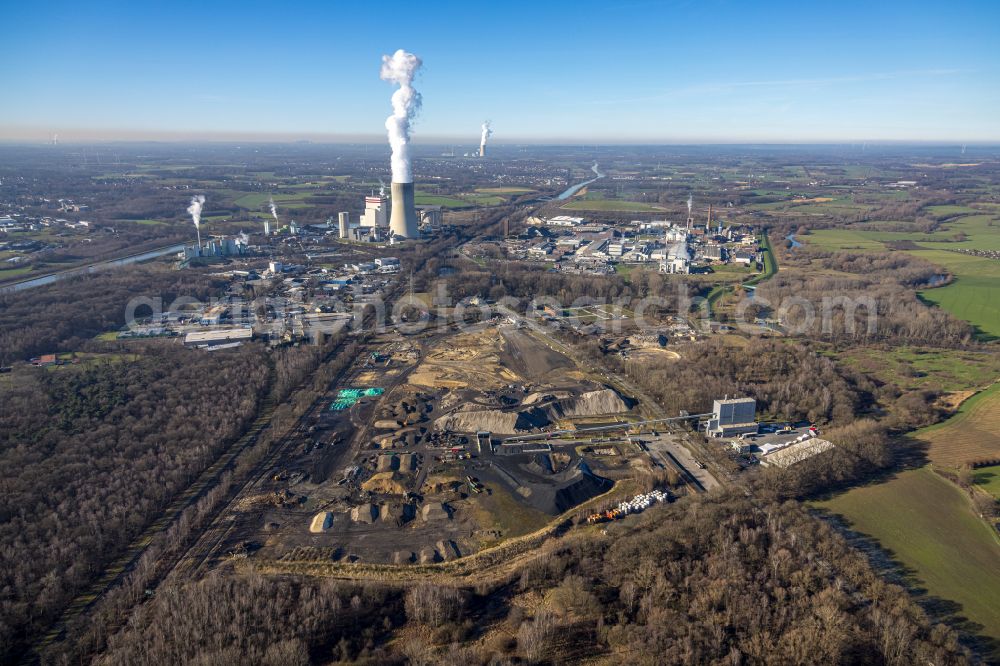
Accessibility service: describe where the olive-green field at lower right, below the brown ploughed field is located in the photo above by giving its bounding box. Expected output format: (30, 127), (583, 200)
(816, 467), (1000, 639)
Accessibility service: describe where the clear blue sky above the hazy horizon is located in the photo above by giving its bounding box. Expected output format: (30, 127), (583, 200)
(0, 0), (1000, 143)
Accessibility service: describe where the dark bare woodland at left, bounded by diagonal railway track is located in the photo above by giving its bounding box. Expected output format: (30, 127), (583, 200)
(0, 343), (270, 659)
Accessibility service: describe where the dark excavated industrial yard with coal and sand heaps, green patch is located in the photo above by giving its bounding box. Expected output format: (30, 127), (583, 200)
(213, 319), (696, 565)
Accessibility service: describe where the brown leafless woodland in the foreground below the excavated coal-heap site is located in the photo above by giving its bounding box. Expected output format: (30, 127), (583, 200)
(92, 492), (968, 665)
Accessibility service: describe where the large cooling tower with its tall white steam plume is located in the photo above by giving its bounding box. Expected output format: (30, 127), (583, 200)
(379, 49), (421, 238)
